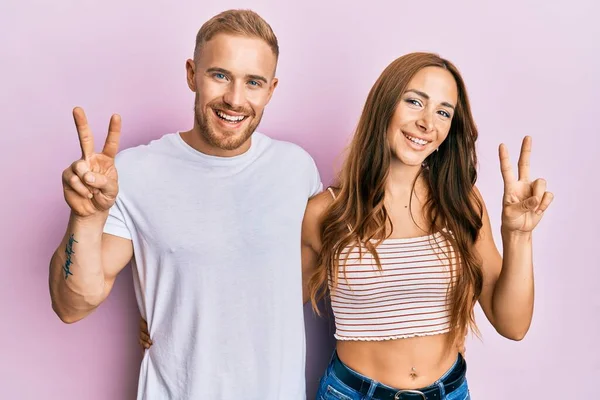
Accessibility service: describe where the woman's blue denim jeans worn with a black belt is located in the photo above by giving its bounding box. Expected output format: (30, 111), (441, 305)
(316, 352), (471, 400)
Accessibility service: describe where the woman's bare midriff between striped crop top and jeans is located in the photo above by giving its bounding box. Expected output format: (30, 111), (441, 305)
(337, 335), (458, 389)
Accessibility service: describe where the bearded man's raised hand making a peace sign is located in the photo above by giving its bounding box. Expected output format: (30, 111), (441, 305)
(62, 107), (121, 218)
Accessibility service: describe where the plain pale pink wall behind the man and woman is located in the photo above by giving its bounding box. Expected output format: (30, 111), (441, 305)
(0, 0), (600, 400)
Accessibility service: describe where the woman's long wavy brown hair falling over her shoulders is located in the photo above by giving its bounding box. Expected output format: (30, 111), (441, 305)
(308, 53), (483, 343)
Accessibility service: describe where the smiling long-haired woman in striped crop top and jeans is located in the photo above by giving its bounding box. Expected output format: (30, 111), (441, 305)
(303, 53), (552, 400)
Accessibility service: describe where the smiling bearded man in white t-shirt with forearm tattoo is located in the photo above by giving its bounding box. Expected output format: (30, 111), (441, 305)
(50, 10), (322, 400)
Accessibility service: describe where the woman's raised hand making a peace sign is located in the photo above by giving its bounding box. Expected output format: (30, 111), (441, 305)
(499, 136), (554, 233)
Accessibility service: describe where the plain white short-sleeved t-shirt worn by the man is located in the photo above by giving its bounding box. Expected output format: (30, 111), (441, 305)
(104, 132), (322, 400)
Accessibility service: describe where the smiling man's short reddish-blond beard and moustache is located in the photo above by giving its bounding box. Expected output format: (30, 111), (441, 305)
(194, 101), (262, 151)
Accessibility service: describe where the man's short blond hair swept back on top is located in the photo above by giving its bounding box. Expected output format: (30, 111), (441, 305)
(194, 10), (279, 61)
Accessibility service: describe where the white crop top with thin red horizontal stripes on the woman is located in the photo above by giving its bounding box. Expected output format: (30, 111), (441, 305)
(329, 189), (454, 341)
